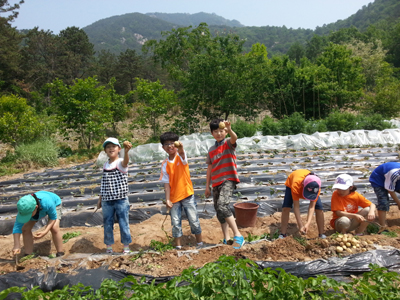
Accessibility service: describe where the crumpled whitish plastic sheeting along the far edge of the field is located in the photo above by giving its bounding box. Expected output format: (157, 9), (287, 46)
(97, 127), (400, 167)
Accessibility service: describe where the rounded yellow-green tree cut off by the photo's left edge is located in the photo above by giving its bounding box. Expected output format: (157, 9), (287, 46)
(0, 95), (46, 147)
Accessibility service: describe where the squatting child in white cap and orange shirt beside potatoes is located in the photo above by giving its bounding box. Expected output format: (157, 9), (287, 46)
(331, 174), (375, 235)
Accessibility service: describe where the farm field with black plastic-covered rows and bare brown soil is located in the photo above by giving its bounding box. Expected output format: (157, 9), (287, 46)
(0, 145), (400, 277)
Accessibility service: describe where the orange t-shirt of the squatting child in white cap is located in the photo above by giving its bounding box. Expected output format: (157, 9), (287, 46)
(331, 191), (371, 228)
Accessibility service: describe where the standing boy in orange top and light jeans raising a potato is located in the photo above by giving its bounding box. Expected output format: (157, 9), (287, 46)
(160, 132), (203, 249)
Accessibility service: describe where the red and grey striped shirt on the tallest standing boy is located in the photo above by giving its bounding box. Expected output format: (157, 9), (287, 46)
(206, 139), (240, 187)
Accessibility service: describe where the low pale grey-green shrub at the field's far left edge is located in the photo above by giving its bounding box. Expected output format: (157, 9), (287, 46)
(15, 139), (59, 167)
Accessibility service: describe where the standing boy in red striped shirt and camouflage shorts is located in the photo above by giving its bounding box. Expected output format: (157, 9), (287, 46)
(205, 119), (244, 249)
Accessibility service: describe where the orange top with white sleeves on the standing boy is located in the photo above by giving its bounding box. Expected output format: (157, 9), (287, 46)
(160, 153), (194, 203)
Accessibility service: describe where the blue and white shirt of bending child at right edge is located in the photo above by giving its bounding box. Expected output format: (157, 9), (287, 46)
(369, 161), (400, 192)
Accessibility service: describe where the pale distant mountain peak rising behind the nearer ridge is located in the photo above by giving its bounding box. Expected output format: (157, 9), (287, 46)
(146, 12), (244, 27)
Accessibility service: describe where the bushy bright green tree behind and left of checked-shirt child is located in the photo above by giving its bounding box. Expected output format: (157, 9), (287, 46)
(49, 77), (113, 149)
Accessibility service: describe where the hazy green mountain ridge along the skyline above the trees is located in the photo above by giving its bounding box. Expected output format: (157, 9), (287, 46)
(83, 0), (400, 55)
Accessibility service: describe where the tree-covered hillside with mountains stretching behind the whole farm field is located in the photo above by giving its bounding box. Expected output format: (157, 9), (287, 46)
(0, 0), (400, 175)
